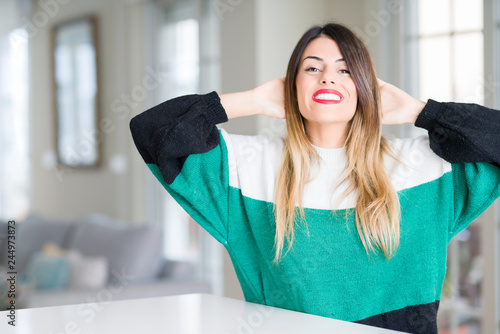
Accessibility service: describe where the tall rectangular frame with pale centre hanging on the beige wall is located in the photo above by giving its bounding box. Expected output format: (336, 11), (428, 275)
(52, 16), (100, 168)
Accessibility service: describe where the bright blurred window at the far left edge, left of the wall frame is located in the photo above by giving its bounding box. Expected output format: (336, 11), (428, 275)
(0, 29), (30, 221)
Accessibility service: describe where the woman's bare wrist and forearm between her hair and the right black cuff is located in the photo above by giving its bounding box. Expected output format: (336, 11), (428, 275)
(378, 79), (425, 124)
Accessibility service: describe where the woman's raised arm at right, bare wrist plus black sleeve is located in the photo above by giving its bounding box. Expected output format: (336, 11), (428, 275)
(379, 80), (500, 167)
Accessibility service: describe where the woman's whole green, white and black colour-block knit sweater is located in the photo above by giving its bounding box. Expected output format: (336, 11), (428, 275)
(131, 93), (500, 333)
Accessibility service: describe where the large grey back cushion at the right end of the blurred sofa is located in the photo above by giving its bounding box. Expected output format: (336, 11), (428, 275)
(68, 214), (163, 284)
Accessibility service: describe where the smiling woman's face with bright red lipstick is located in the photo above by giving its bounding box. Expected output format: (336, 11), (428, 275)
(296, 36), (358, 127)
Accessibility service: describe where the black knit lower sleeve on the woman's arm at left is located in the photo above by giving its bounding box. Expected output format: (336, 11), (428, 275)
(130, 92), (227, 184)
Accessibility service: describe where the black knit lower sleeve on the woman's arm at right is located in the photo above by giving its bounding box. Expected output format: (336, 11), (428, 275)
(415, 100), (500, 167)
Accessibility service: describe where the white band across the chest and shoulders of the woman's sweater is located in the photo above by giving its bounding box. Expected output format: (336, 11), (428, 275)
(221, 129), (451, 210)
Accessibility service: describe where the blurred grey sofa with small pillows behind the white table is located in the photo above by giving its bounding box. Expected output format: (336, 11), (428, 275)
(0, 214), (212, 309)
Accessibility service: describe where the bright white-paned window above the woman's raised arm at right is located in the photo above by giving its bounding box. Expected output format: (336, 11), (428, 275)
(412, 0), (484, 104)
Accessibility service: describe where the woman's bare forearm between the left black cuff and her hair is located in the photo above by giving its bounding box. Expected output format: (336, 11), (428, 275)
(220, 78), (285, 119)
